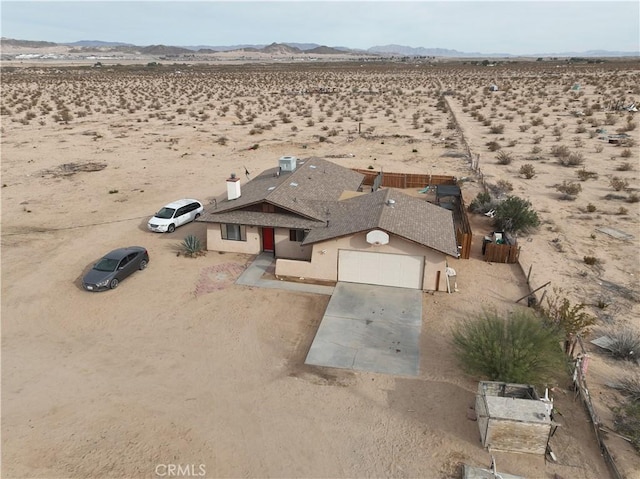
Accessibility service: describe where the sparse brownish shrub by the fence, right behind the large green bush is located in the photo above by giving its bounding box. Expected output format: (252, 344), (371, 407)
(538, 288), (596, 344)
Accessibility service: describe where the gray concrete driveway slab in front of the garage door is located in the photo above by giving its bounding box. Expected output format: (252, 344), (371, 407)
(305, 282), (422, 376)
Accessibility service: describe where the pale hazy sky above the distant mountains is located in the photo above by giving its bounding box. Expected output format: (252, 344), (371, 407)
(0, 0), (640, 54)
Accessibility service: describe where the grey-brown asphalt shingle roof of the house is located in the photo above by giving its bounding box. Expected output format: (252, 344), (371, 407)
(199, 158), (458, 256)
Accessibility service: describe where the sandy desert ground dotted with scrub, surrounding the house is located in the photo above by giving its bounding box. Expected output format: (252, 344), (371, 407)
(0, 57), (640, 479)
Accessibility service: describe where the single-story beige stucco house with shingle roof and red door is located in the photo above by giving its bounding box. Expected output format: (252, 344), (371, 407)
(197, 156), (459, 291)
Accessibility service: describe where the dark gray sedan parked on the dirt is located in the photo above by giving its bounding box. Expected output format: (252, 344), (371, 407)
(82, 246), (149, 291)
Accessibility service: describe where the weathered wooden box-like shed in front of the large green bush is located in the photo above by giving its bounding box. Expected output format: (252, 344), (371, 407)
(476, 381), (557, 454)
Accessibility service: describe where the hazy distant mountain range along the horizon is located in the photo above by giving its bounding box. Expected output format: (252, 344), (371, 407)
(0, 38), (640, 58)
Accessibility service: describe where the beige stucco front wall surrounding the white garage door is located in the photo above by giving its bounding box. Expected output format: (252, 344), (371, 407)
(276, 232), (447, 291)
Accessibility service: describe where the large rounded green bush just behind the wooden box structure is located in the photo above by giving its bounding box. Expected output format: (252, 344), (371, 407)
(453, 310), (564, 384)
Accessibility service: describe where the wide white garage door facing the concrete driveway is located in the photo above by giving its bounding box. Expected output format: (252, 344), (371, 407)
(338, 250), (424, 289)
